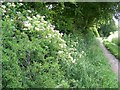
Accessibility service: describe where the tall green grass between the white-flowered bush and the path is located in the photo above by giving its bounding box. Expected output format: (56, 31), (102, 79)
(64, 33), (118, 88)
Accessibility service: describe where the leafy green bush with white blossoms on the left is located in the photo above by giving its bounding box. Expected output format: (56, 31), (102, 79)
(2, 3), (73, 88)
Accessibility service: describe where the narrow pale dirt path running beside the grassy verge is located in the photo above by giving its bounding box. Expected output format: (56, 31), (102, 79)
(97, 38), (120, 77)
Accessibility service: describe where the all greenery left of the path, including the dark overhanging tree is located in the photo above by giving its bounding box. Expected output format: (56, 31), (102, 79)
(0, 2), (118, 88)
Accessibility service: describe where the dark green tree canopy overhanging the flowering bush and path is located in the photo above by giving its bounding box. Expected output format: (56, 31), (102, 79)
(19, 2), (119, 33)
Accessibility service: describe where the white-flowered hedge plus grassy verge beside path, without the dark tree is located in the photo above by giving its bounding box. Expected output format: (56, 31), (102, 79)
(1, 3), (117, 88)
